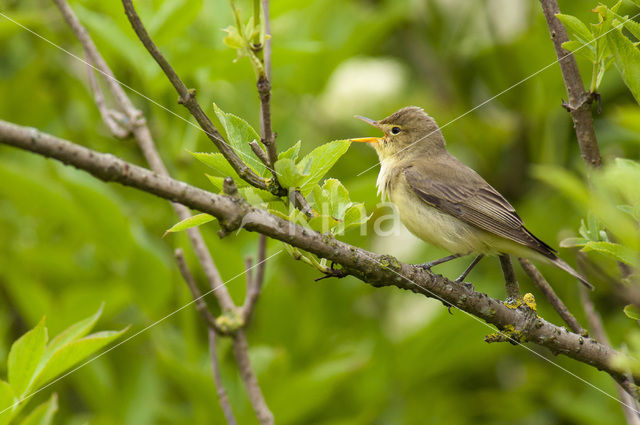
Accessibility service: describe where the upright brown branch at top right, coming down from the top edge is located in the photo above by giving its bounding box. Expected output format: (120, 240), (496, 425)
(540, 0), (602, 167)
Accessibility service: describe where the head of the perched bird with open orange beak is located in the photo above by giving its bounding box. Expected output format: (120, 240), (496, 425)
(351, 106), (445, 161)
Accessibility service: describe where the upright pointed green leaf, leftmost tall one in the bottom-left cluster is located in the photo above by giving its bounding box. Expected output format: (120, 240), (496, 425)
(8, 318), (47, 398)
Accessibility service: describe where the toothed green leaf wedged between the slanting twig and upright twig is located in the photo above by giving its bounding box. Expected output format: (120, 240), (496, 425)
(213, 103), (266, 175)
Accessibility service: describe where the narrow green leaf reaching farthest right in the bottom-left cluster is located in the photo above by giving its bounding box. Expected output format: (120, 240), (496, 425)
(34, 328), (127, 387)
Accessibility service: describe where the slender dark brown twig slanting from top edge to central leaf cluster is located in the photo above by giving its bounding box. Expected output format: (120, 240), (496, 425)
(122, 0), (268, 190)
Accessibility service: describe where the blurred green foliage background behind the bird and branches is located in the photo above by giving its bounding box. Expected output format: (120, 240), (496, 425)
(0, 0), (640, 425)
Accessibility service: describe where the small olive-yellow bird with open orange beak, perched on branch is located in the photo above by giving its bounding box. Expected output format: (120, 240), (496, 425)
(351, 106), (593, 288)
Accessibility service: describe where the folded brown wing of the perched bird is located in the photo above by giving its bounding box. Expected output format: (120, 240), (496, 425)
(403, 156), (556, 259)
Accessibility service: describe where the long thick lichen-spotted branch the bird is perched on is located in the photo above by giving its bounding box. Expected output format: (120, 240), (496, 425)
(0, 120), (639, 398)
